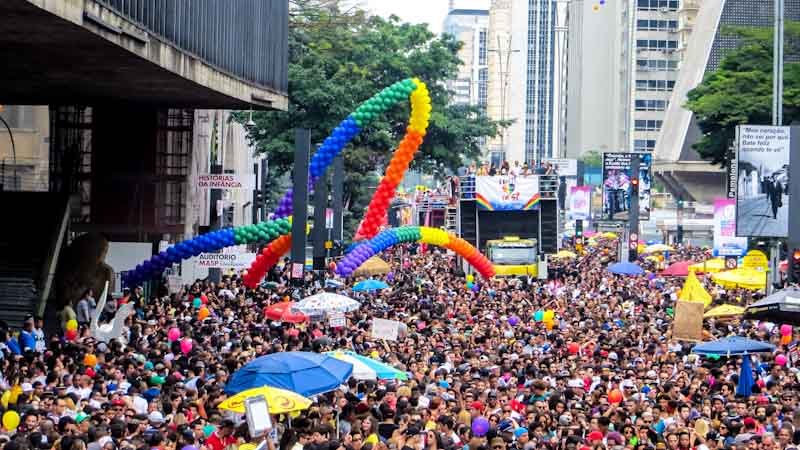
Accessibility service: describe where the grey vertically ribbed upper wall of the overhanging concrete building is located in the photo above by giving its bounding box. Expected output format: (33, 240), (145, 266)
(95, 0), (289, 93)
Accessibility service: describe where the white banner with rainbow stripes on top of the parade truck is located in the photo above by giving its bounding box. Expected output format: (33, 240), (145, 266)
(475, 175), (540, 211)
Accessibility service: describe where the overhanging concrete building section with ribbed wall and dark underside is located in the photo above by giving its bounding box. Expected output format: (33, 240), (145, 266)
(0, 0), (288, 110)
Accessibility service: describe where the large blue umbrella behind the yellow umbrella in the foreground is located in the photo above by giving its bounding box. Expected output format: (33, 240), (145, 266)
(225, 352), (353, 397)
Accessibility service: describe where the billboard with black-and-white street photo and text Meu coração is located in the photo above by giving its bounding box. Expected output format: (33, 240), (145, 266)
(736, 125), (789, 237)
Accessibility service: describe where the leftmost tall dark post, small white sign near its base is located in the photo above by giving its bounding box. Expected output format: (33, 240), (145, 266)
(291, 128), (311, 285)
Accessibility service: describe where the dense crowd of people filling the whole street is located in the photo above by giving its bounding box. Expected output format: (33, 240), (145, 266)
(0, 236), (800, 450)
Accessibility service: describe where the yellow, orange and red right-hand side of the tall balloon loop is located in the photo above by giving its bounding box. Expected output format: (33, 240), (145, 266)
(354, 78), (431, 240)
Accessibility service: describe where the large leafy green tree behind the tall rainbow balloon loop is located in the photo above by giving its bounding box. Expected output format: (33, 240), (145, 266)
(237, 0), (503, 239)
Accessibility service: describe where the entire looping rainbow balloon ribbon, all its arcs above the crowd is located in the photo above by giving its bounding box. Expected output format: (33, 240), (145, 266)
(122, 78), (494, 287)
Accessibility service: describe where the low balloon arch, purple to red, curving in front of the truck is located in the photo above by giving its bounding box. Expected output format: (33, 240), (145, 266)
(336, 227), (495, 279)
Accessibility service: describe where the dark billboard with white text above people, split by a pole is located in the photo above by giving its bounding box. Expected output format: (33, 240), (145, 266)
(602, 152), (653, 220)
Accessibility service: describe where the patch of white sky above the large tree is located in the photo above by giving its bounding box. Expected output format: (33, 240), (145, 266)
(354, 0), (490, 34)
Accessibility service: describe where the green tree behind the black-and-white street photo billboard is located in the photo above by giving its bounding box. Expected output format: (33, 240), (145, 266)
(685, 22), (800, 164)
